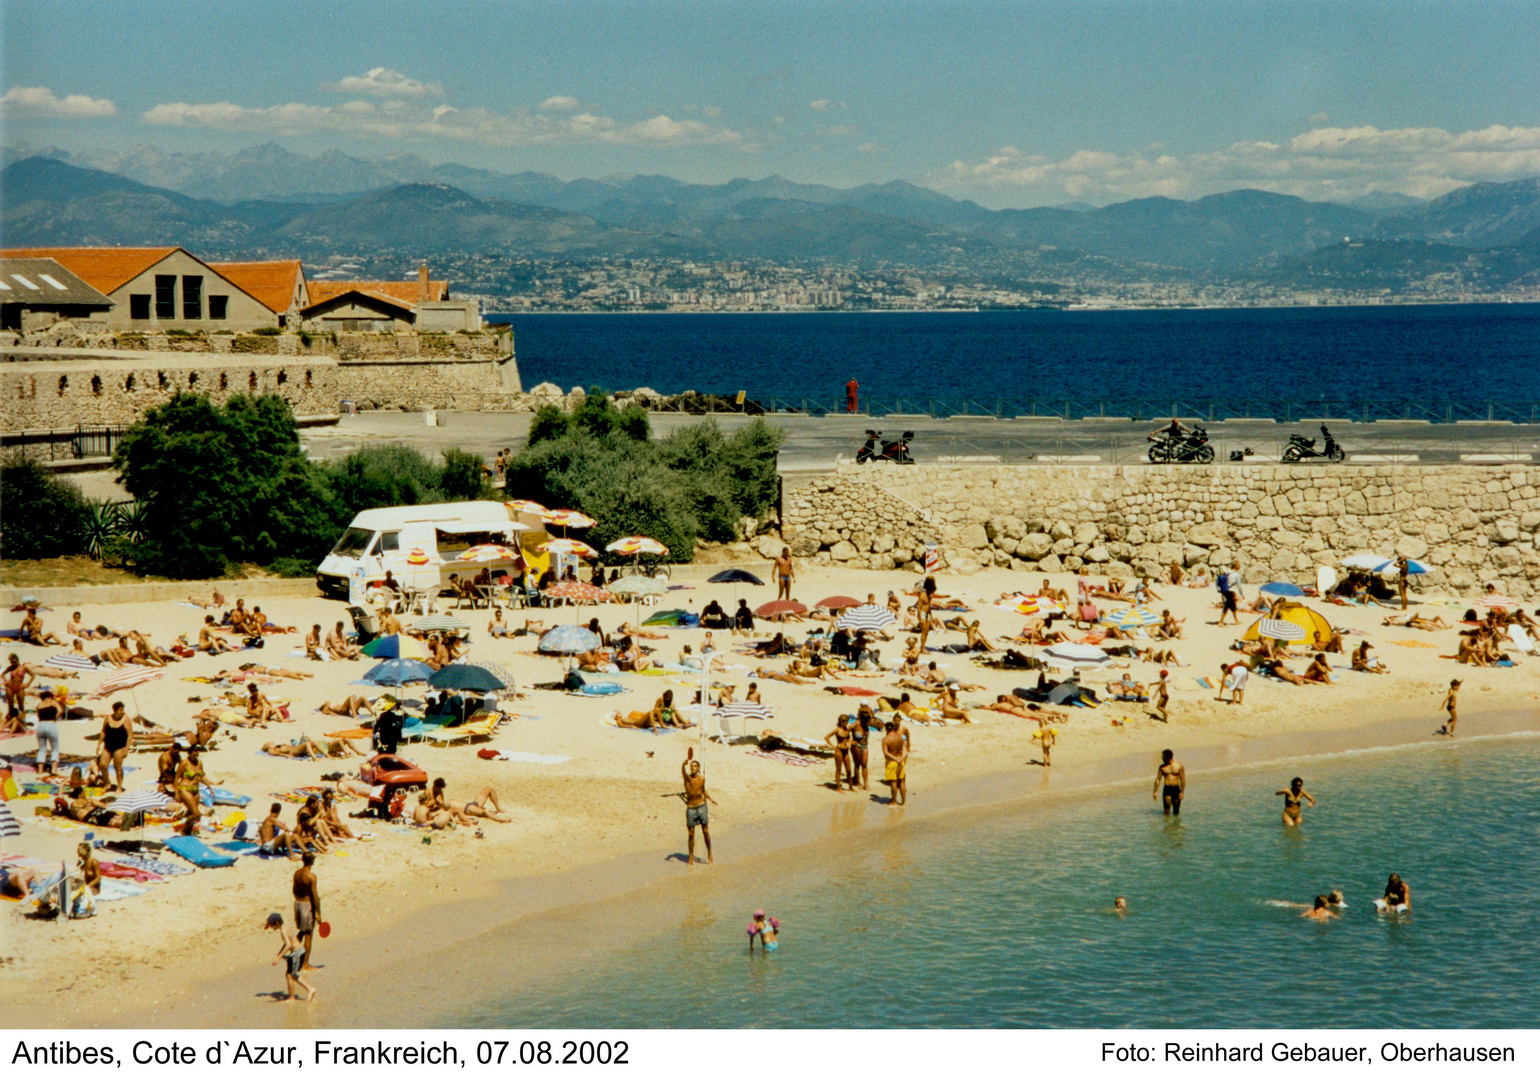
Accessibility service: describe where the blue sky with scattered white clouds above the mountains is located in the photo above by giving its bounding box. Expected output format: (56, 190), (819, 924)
(0, 0), (1540, 208)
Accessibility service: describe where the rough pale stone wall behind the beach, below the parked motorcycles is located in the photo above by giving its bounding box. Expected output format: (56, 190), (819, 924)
(781, 465), (1540, 598)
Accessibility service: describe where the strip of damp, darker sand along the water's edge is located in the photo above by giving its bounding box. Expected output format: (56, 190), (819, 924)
(100, 699), (1540, 1028)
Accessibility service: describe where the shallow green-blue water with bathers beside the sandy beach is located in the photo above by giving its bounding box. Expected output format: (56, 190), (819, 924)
(454, 736), (1540, 1028)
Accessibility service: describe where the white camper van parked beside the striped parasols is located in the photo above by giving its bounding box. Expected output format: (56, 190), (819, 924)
(316, 502), (531, 596)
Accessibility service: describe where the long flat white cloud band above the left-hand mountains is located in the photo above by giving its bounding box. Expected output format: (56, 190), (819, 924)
(142, 100), (742, 146)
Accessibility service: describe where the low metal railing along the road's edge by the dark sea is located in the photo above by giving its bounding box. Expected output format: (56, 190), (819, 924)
(656, 396), (1540, 424)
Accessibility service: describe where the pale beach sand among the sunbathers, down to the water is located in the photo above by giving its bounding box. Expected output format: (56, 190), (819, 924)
(0, 567), (1540, 1028)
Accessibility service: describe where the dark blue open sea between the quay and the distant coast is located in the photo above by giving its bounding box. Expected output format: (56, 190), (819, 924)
(493, 304), (1540, 402)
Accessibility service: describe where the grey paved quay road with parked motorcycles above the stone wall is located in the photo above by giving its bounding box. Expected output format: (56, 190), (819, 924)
(303, 413), (1540, 473)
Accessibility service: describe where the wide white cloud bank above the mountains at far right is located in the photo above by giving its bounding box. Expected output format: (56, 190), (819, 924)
(936, 125), (1540, 202)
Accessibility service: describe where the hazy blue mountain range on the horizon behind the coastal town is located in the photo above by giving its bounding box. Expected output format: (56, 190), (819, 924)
(0, 145), (1540, 290)
